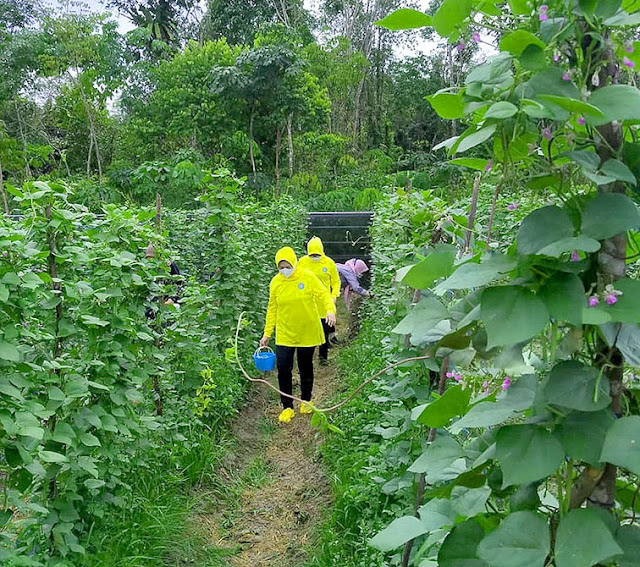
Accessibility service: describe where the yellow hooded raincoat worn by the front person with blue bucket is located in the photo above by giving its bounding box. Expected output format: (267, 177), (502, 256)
(264, 246), (335, 347)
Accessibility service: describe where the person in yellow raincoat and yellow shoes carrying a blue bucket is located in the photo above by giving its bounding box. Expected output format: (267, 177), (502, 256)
(260, 246), (336, 423)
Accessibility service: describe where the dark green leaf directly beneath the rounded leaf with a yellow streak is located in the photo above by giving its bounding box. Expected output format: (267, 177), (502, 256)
(558, 408), (615, 468)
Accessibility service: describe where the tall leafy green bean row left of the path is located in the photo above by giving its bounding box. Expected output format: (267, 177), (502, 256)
(0, 172), (306, 566)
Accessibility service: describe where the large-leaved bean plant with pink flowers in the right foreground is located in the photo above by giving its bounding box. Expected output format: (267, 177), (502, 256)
(370, 0), (640, 567)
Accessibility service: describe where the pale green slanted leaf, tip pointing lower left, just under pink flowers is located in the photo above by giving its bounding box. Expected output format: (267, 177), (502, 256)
(450, 375), (538, 435)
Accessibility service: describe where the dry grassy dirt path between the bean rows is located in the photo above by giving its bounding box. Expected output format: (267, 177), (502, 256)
(194, 352), (336, 567)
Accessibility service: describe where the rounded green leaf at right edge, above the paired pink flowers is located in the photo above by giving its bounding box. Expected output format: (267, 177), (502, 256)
(582, 193), (640, 240)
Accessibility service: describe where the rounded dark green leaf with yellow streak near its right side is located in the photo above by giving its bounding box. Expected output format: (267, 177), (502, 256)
(544, 360), (611, 412)
